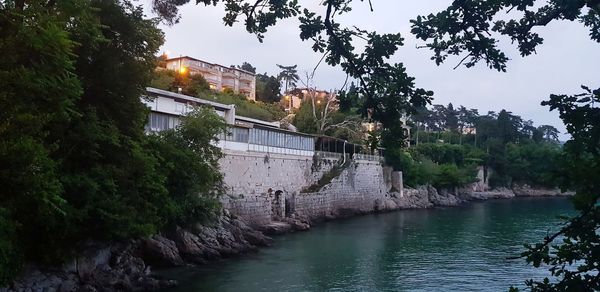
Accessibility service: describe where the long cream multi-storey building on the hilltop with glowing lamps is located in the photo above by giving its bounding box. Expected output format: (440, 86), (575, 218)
(165, 56), (256, 100)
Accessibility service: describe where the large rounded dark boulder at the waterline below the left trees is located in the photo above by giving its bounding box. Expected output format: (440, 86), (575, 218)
(140, 235), (183, 267)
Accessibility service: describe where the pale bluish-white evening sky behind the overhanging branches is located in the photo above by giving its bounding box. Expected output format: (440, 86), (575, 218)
(146, 0), (600, 139)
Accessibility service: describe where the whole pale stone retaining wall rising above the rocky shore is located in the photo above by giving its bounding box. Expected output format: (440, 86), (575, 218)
(222, 154), (403, 226)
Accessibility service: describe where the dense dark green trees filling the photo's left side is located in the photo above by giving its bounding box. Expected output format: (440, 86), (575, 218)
(0, 0), (225, 283)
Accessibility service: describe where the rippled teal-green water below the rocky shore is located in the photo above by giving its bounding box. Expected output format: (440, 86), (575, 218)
(164, 198), (573, 291)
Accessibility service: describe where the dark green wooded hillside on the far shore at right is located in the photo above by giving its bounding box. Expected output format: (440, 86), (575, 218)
(409, 104), (562, 187)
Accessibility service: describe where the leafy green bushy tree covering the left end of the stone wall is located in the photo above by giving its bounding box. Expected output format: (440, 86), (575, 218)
(147, 108), (226, 225)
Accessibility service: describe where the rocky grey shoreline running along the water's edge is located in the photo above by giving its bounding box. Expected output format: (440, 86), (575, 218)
(0, 186), (572, 292)
